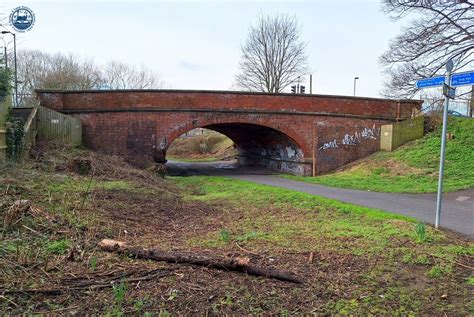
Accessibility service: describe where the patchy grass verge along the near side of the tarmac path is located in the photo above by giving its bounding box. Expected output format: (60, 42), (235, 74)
(173, 176), (474, 315)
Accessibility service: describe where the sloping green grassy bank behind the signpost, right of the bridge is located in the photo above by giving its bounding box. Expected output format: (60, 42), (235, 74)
(283, 118), (474, 193)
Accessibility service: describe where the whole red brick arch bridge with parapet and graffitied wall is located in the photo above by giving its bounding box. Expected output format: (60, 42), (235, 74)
(36, 90), (421, 175)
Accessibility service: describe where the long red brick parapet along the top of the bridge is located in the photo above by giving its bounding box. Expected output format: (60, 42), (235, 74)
(36, 89), (421, 121)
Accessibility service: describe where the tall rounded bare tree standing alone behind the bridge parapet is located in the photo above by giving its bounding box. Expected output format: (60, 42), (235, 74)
(235, 15), (308, 93)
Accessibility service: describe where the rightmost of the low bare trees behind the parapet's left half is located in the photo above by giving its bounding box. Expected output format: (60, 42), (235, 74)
(102, 61), (163, 89)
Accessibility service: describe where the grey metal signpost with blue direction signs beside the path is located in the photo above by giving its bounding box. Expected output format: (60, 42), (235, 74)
(416, 59), (474, 228)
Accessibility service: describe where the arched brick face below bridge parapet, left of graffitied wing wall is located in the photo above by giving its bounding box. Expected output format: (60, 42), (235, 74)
(74, 112), (313, 174)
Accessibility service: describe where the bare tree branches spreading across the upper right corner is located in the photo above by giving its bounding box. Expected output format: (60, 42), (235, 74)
(380, 0), (474, 98)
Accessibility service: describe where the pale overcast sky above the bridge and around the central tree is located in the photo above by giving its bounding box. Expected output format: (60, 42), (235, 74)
(0, 0), (408, 97)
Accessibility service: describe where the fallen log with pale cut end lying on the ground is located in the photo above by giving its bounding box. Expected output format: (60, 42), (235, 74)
(99, 239), (303, 284)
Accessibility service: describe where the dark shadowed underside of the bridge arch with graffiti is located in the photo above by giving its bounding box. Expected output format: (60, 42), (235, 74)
(165, 123), (312, 175)
